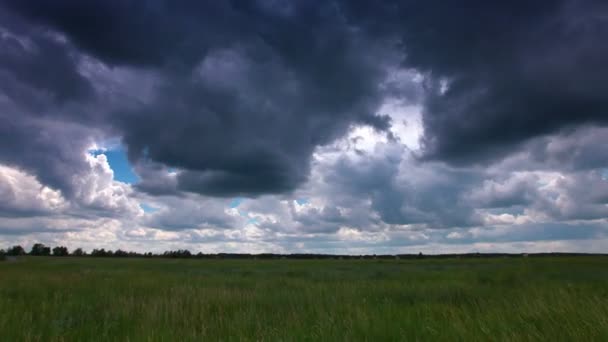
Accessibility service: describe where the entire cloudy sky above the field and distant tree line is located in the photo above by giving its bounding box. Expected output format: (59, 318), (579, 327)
(0, 0), (608, 254)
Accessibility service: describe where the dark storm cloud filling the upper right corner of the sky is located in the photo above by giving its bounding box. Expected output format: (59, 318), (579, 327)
(346, 0), (608, 164)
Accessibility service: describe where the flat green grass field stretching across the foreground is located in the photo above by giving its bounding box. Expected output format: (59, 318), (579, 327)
(0, 257), (608, 341)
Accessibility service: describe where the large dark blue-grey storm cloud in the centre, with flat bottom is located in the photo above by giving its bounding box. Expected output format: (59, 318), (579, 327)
(6, 1), (397, 196)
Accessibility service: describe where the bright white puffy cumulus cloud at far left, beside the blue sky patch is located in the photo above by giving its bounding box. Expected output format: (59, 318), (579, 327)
(0, 154), (143, 233)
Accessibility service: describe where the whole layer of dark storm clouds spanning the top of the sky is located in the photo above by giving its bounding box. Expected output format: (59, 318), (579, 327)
(0, 0), (608, 200)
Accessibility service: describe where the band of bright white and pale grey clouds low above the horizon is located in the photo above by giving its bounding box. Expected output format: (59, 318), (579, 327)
(0, 119), (608, 254)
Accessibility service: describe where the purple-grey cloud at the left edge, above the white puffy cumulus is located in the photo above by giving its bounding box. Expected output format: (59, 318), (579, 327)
(0, 8), (100, 196)
